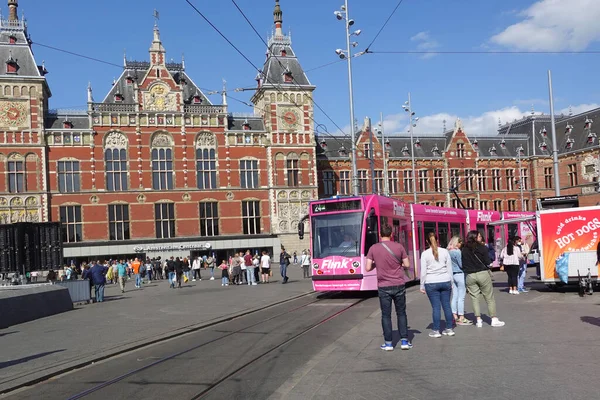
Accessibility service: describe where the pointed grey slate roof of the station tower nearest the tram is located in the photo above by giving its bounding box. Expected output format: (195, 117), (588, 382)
(259, 0), (314, 89)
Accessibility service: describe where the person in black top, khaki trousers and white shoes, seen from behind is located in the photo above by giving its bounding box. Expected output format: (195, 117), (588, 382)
(461, 231), (504, 328)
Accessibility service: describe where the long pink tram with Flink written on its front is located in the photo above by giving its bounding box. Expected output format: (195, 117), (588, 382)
(298, 195), (534, 291)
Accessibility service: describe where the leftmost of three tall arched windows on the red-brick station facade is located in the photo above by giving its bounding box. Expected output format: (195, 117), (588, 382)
(104, 132), (128, 192)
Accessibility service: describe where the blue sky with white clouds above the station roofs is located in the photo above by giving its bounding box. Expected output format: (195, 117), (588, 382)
(17, 0), (600, 135)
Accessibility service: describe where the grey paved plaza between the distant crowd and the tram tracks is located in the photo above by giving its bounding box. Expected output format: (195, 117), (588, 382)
(0, 265), (312, 392)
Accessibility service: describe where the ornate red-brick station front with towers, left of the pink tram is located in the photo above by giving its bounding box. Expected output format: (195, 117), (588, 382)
(0, 0), (317, 259)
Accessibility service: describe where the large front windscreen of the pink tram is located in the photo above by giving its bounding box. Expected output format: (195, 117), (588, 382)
(312, 212), (363, 258)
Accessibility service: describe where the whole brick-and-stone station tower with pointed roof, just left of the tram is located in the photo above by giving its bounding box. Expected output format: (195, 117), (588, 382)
(252, 0), (318, 252)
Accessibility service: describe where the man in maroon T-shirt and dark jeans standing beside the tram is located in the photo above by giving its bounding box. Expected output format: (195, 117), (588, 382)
(366, 224), (412, 351)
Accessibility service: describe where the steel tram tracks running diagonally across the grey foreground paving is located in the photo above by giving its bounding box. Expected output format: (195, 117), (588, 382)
(7, 292), (368, 400)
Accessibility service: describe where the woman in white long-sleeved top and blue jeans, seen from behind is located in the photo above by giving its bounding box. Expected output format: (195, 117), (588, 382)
(421, 232), (454, 338)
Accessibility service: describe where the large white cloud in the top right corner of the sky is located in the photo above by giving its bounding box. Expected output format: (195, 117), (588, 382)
(491, 0), (600, 51)
